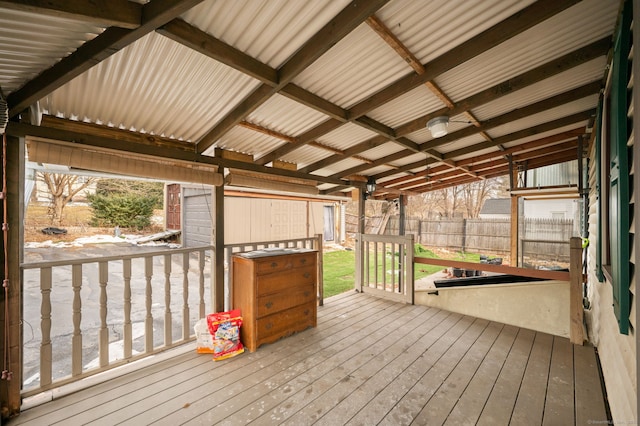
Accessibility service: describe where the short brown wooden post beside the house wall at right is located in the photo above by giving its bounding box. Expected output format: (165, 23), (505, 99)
(569, 237), (584, 345)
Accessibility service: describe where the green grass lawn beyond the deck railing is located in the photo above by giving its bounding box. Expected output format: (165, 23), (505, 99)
(322, 244), (448, 298)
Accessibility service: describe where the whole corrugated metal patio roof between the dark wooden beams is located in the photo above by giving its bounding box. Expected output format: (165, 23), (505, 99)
(0, 0), (619, 196)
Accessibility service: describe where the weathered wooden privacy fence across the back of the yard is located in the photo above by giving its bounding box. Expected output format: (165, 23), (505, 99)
(347, 216), (573, 261)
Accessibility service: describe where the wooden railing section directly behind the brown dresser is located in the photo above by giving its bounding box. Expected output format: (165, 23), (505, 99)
(224, 234), (324, 309)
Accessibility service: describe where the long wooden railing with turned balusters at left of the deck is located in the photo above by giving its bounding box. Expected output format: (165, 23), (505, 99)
(21, 246), (213, 397)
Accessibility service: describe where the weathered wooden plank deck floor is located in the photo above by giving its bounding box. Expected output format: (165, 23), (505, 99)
(8, 292), (607, 426)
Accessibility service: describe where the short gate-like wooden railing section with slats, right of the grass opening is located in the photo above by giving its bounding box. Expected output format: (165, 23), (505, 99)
(356, 234), (414, 304)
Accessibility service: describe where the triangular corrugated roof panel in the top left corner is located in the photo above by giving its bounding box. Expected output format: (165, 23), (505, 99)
(0, 9), (103, 96)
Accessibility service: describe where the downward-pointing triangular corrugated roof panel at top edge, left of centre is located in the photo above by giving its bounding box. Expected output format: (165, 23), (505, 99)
(182, 0), (349, 68)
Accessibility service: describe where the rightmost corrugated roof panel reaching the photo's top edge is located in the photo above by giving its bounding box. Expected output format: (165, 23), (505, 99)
(436, 0), (619, 101)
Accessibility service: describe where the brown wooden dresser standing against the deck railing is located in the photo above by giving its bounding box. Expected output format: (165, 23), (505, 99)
(232, 250), (318, 352)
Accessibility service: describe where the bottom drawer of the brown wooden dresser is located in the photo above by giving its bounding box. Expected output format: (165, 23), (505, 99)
(256, 301), (316, 345)
